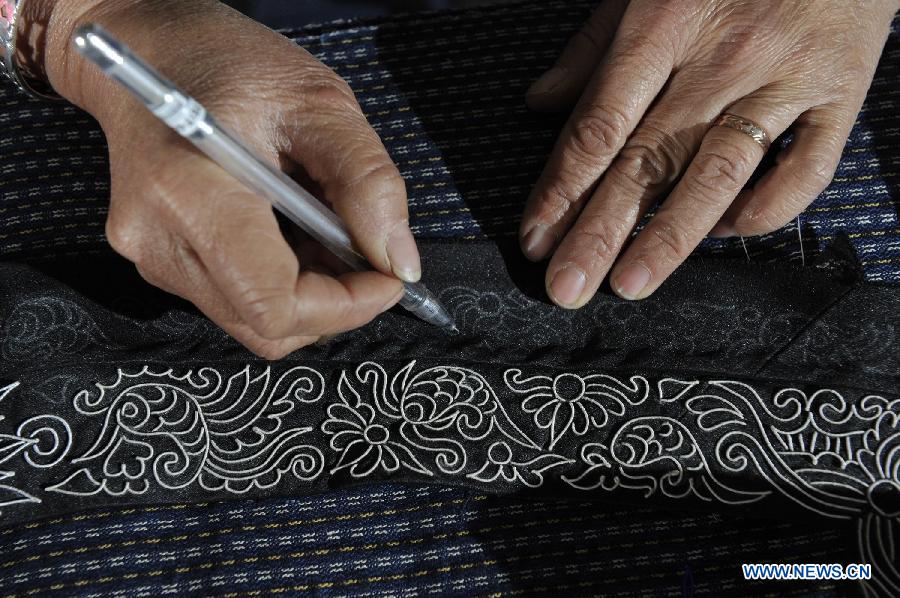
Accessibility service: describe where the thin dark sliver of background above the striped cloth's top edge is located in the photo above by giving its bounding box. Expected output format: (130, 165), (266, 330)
(224, 0), (508, 29)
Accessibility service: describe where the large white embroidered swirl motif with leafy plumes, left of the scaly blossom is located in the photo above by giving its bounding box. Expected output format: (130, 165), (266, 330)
(46, 366), (324, 496)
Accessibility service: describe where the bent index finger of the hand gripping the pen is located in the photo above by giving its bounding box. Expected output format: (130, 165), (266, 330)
(163, 155), (403, 339)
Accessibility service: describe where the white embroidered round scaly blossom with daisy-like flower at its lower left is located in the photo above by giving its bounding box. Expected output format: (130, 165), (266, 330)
(322, 361), (538, 477)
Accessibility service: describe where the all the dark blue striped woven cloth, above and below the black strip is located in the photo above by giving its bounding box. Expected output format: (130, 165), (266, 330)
(0, 0), (900, 596)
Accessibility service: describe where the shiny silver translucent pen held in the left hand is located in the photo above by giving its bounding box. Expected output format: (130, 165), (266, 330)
(74, 24), (457, 332)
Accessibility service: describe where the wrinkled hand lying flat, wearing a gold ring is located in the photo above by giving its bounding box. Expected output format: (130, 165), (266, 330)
(520, 0), (900, 308)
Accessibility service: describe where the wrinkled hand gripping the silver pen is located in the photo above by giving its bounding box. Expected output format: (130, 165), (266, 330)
(33, 0), (420, 359)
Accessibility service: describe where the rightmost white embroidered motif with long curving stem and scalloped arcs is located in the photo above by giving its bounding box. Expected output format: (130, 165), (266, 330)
(682, 380), (900, 518)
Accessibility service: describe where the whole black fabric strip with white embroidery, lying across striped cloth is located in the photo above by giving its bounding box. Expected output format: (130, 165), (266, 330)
(0, 243), (900, 523)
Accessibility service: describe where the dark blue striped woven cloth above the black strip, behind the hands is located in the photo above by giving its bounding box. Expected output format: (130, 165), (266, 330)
(0, 0), (900, 282)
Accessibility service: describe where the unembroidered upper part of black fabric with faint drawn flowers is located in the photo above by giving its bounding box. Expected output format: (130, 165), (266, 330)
(0, 241), (900, 393)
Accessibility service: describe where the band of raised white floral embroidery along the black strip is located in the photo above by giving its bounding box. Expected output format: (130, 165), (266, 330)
(0, 361), (900, 587)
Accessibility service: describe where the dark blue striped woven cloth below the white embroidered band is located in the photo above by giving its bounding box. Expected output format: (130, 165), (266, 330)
(0, 486), (855, 596)
